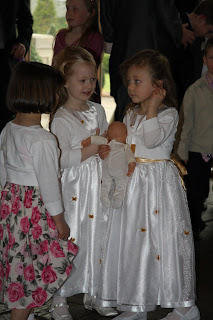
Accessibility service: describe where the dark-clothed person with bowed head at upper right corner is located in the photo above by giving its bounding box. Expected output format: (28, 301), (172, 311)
(172, 0), (213, 107)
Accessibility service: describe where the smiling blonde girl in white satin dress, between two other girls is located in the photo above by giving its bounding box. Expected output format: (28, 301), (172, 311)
(51, 47), (117, 320)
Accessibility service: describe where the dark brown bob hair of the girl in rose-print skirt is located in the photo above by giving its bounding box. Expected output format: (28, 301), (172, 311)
(7, 61), (65, 113)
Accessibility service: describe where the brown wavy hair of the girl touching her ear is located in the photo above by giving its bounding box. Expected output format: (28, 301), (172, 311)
(120, 49), (177, 110)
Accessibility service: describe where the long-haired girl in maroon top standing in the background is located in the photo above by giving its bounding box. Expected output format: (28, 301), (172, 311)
(53, 0), (104, 103)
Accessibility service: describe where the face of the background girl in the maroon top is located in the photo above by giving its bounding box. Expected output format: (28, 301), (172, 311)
(66, 0), (90, 28)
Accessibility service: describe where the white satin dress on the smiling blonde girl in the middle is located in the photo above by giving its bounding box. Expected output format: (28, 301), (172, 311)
(51, 102), (108, 297)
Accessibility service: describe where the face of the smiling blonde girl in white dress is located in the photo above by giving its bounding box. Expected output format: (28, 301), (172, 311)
(65, 63), (96, 103)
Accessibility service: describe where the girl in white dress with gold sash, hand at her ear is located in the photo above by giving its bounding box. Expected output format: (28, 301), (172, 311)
(96, 50), (200, 320)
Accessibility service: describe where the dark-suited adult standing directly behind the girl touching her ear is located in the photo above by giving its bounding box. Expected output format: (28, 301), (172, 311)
(100, 0), (186, 121)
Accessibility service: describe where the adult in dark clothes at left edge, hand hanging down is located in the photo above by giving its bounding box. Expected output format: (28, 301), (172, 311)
(0, 0), (33, 131)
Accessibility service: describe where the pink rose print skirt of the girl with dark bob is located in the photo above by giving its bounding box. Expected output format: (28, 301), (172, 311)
(0, 183), (78, 309)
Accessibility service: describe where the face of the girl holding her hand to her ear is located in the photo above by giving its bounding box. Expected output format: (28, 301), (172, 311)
(127, 66), (155, 103)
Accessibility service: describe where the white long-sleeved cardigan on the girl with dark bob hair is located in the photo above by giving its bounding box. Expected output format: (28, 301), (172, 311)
(0, 122), (63, 216)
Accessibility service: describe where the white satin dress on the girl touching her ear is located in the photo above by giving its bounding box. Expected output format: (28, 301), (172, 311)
(96, 108), (195, 312)
